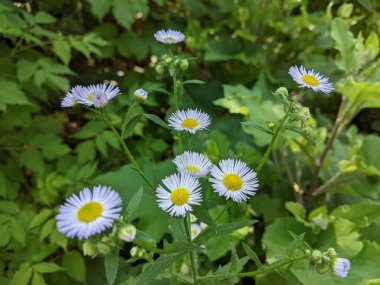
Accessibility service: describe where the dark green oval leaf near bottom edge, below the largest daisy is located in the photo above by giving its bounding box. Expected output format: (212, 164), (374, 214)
(62, 250), (86, 282)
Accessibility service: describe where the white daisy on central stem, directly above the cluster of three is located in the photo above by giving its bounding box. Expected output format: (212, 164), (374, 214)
(169, 109), (211, 134)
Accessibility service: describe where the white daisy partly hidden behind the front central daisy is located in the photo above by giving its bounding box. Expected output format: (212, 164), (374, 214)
(173, 151), (212, 178)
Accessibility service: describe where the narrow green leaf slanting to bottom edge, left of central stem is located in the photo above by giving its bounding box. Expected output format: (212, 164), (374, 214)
(136, 253), (183, 285)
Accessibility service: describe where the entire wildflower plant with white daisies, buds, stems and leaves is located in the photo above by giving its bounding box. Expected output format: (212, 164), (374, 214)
(52, 27), (350, 284)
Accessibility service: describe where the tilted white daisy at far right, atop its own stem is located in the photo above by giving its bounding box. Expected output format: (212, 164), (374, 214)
(289, 65), (334, 94)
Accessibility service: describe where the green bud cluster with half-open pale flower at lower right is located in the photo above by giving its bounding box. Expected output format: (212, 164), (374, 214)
(305, 247), (351, 278)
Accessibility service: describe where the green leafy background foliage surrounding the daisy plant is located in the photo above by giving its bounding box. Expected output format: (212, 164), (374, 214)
(0, 0), (380, 285)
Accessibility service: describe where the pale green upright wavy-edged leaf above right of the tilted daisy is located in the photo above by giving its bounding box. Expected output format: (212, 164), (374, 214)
(331, 18), (356, 73)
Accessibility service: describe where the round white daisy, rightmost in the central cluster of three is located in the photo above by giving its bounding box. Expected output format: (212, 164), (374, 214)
(209, 159), (259, 203)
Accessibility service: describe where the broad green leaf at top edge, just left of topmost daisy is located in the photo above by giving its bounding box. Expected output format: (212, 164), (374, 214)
(112, 0), (149, 30)
